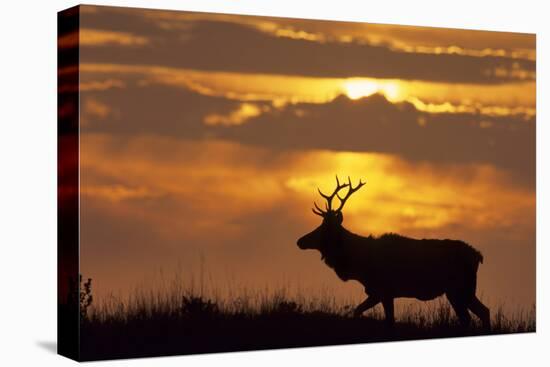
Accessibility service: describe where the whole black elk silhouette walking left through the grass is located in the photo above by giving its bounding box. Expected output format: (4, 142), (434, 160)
(298, 176), (490, 329)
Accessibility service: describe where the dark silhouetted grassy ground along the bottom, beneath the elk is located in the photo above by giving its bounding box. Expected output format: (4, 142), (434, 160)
(77, 276), (536, 360)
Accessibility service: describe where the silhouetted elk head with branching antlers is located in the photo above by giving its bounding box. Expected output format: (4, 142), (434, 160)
(298, 176), (365, 250)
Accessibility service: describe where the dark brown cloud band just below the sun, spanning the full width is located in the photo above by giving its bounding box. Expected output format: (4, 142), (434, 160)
(82, 82), (536, 185)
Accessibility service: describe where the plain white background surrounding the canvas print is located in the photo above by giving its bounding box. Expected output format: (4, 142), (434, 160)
(0, 0), (550, 367)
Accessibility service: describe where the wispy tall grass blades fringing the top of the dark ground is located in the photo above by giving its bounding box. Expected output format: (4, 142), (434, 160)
(82, 272), (536, 332)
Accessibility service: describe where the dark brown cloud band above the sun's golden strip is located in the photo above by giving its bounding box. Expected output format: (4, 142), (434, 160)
(81, 8), (535, 83)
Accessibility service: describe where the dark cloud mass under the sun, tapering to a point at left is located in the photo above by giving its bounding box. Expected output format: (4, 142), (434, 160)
(215, 95), (536, 183)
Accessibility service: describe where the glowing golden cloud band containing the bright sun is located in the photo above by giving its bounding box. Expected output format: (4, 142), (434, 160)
(75, 63), (536, 117)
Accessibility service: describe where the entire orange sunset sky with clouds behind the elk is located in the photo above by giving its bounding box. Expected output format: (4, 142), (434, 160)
(64, 6), (536, 307)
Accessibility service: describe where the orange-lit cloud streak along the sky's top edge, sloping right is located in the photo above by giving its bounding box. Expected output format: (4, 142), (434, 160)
(132, 6), (536, 60)
